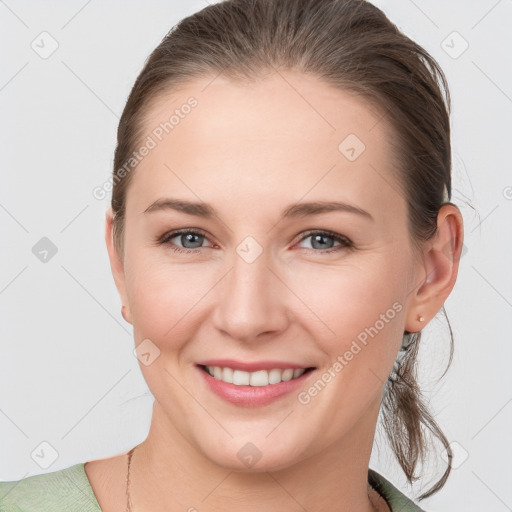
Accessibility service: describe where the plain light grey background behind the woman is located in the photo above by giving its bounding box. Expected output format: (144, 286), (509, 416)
(0, 0), (512, 512)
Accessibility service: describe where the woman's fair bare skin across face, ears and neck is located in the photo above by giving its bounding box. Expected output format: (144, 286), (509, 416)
(86, 70), (463, 512)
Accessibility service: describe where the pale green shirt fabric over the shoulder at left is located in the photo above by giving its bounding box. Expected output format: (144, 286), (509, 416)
(0, 463), (101, 512)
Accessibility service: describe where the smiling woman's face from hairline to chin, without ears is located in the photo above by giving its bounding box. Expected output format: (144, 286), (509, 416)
(109, 71), (428, 471)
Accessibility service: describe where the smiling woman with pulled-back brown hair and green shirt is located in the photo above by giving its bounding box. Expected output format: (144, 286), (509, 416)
(0, 0), (463, 512)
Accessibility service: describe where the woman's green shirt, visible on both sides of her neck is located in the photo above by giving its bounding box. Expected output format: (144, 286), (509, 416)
(0, 462), (424, 512)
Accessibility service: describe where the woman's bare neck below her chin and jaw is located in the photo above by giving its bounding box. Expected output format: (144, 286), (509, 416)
(130, 402), (384, 512)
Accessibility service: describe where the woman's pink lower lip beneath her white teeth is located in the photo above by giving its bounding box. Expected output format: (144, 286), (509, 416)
(197, 366), (313, 407)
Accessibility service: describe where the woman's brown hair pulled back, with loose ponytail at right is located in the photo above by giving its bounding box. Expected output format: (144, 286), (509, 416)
(111, 0), (453, 499)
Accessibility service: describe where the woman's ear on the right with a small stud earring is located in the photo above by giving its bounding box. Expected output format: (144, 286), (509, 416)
(405, 203), (464, 332)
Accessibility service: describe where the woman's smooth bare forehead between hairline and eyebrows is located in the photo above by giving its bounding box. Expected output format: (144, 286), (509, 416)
(127, 71), (402, 224)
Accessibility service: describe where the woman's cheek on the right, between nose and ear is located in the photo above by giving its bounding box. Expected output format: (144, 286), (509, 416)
(292, 254), (407, 375)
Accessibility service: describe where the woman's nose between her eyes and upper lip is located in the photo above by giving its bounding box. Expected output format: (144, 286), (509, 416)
(213, 248), (291, 343)
